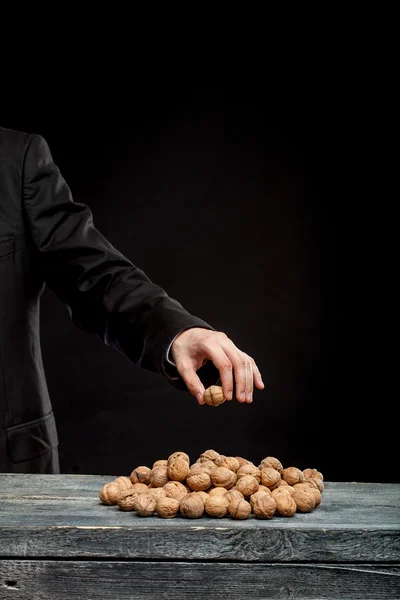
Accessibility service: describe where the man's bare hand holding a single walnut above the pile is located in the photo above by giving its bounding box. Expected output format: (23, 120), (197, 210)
(171, 327), (264, 404)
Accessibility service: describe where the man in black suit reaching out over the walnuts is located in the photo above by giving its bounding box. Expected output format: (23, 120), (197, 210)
(0, 128), (264, 473)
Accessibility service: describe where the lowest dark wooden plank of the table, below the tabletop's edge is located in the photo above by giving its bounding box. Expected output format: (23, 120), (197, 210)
(0, 560), (400, 600)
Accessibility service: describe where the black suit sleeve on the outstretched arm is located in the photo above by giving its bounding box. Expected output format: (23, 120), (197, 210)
(22, 135), (219, 390)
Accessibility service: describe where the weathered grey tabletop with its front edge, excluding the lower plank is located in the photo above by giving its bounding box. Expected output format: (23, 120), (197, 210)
(0, 474), (400, 563)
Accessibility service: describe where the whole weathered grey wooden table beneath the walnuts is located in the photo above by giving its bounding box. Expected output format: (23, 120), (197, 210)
(0, 474), (400, 600)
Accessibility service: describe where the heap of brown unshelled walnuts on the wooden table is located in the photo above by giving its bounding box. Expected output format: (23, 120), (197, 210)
(100, 450), (324, 519)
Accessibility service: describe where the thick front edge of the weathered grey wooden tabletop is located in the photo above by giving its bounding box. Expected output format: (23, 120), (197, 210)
(0, 519), (400, 563)
